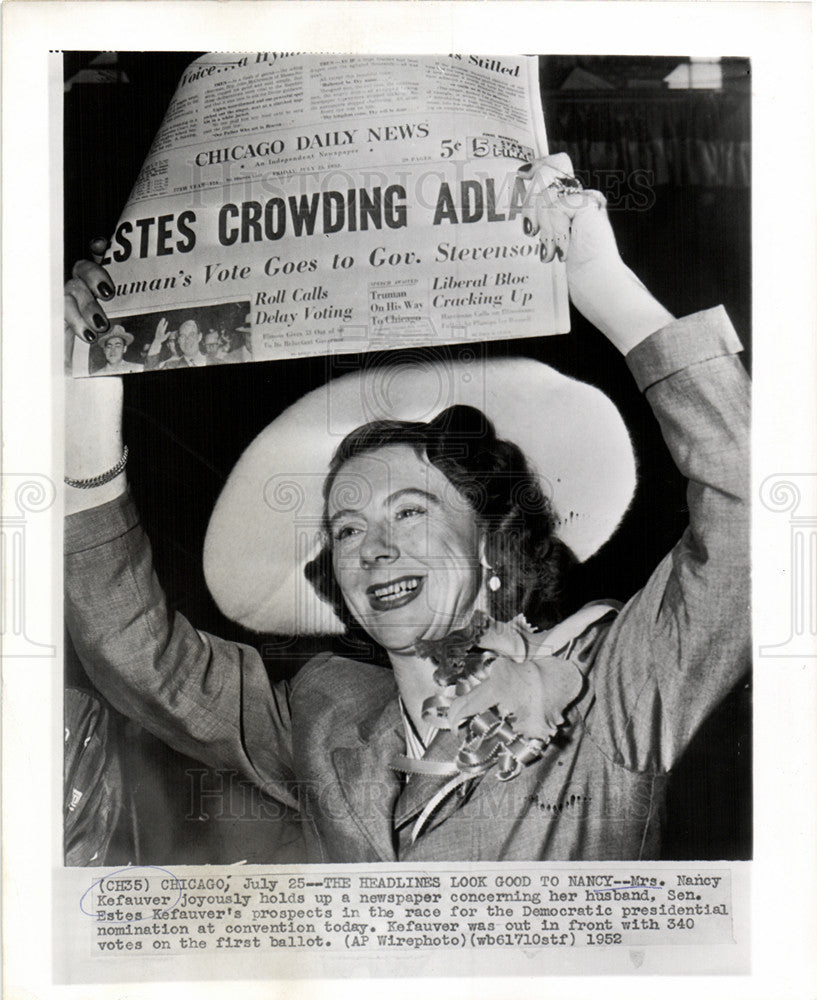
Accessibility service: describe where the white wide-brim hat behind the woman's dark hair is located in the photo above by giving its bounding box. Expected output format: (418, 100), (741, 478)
(204, 358), (635, 635)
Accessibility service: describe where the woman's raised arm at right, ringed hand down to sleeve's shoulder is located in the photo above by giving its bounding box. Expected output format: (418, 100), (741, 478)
(526, 156), (750, 772)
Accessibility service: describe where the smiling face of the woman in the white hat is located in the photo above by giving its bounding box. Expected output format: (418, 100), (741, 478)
(327, 445), (482, 652)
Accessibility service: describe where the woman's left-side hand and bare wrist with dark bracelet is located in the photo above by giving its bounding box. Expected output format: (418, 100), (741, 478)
(64, 254), (125, 514)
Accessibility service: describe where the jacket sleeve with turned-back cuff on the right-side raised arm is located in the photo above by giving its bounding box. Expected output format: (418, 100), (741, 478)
(585, 308), (750, 772)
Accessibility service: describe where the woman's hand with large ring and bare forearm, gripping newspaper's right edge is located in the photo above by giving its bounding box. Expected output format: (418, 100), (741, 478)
(520, 153), (673, 354)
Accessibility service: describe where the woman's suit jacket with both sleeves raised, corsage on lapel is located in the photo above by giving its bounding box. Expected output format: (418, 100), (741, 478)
(65, 309), (749, 862)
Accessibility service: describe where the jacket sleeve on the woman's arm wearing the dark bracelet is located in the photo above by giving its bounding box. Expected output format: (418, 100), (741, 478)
(65, 494), (297, 808)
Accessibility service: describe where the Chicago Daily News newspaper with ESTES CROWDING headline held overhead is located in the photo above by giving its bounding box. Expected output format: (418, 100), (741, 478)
(88, 52), (568, 374)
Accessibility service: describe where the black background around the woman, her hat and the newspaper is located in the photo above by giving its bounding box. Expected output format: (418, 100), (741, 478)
(64, 52), (751, 863)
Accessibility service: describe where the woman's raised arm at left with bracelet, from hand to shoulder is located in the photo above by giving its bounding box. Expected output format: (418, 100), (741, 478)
(64, 261), (296, 807)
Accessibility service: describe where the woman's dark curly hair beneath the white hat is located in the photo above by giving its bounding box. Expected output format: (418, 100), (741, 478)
(304, 406), (576, 629)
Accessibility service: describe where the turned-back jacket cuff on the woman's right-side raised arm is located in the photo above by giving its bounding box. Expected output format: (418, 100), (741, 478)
(626, 306), (743, 392)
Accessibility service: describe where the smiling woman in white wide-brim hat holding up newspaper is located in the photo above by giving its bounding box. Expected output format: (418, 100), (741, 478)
(65, 52), (750, 863)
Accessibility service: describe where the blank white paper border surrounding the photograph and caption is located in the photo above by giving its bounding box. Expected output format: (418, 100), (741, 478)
(2, 0), (817, 1000)
